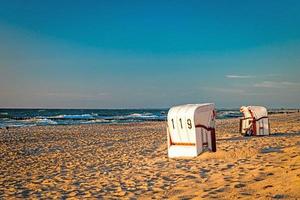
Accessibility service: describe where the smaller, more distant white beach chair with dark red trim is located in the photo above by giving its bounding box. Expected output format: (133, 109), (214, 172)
(240, 106), (270, 136)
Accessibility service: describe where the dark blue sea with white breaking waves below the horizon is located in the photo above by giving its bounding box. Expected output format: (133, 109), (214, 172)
(0, 109), (296, 128)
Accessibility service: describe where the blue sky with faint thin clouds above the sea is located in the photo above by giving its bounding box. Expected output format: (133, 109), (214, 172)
(0, 0), (300, 108)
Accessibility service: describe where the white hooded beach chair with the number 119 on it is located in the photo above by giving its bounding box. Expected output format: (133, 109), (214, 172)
(167, 103), (216, 158)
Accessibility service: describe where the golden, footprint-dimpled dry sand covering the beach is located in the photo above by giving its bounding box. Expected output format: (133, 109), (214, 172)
(0, 113), (300, 199)
